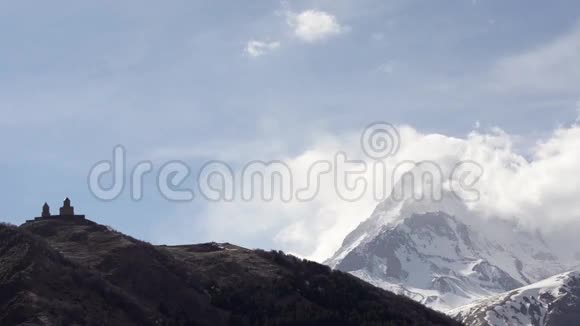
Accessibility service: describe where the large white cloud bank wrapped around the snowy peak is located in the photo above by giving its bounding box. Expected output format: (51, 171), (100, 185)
(172, 124), (580, 261)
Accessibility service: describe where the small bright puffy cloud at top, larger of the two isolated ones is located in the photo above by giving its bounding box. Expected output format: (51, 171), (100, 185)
(287, 10), (345, 43)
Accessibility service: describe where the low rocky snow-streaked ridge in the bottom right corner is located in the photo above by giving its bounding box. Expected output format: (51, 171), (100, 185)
(448, 272), (580, 326)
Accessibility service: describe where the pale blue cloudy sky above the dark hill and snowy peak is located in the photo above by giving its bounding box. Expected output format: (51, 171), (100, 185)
(0, 0), (580, 260)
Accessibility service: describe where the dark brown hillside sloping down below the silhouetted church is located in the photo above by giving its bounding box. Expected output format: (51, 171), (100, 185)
(0, 202), (458, 325)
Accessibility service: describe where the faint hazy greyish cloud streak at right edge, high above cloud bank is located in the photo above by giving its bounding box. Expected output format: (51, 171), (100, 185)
(493, 22), (580, 94)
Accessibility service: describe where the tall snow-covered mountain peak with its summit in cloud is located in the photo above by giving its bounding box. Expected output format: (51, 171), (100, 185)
(326, 193), (567, 310)
